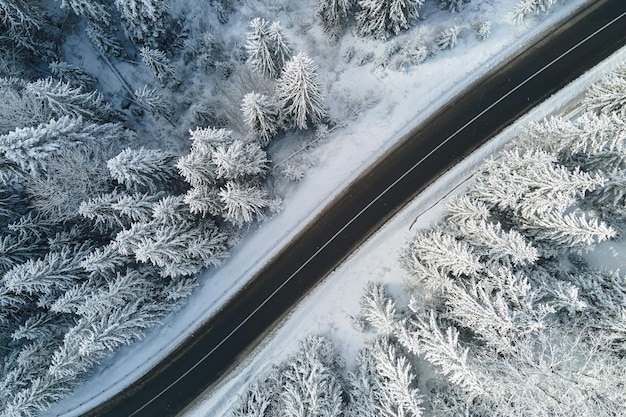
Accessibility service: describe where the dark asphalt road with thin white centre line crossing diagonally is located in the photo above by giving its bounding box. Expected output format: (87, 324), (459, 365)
(85, 0), (626, 417)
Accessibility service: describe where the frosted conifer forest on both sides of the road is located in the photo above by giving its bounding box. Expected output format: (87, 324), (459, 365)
(0, 0), (626, 417)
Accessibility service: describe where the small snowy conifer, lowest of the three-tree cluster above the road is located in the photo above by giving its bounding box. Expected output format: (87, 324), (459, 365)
(241, 92), (279, 145)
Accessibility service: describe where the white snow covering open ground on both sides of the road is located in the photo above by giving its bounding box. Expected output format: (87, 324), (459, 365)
(43, 0), (626, 416)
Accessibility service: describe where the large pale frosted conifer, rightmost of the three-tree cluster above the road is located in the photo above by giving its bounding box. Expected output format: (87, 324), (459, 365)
(276, 52), (325, 129)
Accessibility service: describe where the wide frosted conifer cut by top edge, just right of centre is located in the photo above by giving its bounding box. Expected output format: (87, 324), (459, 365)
(356, 0), (424, 40)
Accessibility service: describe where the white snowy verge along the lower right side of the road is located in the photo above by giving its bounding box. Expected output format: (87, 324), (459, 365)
(184, 39), (626, 417)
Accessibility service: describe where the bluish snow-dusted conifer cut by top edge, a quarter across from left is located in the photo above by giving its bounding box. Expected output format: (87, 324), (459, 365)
(114, 0), (169, 46)
